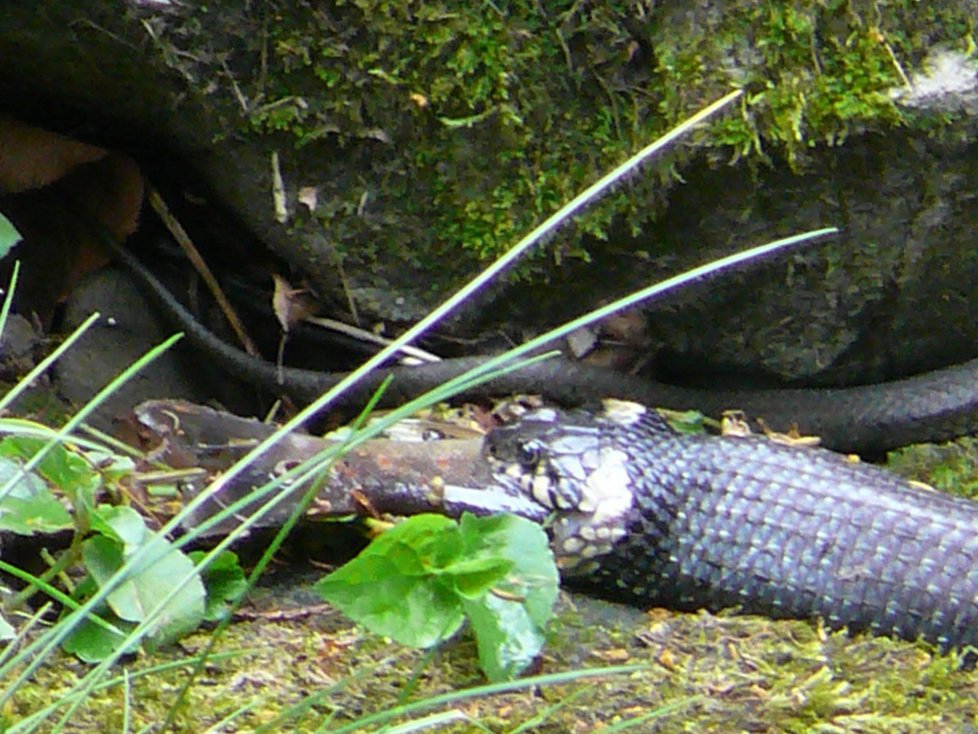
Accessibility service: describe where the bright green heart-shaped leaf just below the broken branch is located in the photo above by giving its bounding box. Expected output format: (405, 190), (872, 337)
(316, 515), (464, 647)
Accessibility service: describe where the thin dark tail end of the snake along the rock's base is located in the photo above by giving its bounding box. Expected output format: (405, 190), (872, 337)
(106, 241), (978, 454)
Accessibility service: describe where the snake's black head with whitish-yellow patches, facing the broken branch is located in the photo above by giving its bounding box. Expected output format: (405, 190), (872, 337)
(483, 401), (645, 573)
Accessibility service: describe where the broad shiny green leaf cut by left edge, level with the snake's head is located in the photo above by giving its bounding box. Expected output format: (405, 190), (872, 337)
(0, 457), (72, 535)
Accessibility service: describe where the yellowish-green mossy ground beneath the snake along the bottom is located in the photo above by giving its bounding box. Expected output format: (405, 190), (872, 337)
(11, 439), (978, 733)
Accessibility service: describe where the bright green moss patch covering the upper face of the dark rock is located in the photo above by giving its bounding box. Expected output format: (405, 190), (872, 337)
(240, 0), (973, 288)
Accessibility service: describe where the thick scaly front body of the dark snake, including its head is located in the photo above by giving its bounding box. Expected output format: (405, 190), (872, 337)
(486, 401), (978, 649)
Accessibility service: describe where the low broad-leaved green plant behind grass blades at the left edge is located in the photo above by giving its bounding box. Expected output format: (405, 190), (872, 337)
(0, 408), (254, 662)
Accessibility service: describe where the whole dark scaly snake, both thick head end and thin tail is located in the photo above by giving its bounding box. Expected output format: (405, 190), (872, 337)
(110, 250), (978, 650)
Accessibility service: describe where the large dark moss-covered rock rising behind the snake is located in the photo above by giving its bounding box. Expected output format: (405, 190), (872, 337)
(0, 0), (975, 379)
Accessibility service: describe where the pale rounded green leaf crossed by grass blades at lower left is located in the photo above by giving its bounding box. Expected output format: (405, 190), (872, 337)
(82, 506), (206, 646)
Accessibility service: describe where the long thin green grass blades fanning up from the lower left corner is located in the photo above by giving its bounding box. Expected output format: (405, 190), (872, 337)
(0, 91), (834, 734)
